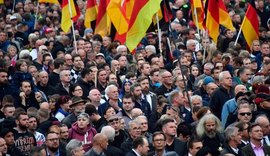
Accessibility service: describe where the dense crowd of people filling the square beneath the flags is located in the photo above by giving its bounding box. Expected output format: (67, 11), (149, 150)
(0, 0), (270, 156)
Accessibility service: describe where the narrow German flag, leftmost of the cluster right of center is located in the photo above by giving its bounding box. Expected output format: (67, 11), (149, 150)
(190, 0), (204, 30)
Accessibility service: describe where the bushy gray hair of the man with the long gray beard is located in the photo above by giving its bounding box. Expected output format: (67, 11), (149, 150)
(196, 114), (222, 137)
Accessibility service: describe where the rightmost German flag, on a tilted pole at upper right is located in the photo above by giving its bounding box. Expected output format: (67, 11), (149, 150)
(241, 0), (259, 48)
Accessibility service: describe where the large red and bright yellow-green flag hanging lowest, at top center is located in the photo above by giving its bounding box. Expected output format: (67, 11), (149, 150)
(126, 0), (161, 51)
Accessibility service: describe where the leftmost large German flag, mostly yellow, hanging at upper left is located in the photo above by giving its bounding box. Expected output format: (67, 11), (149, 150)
(61, 0), (77, 33)
